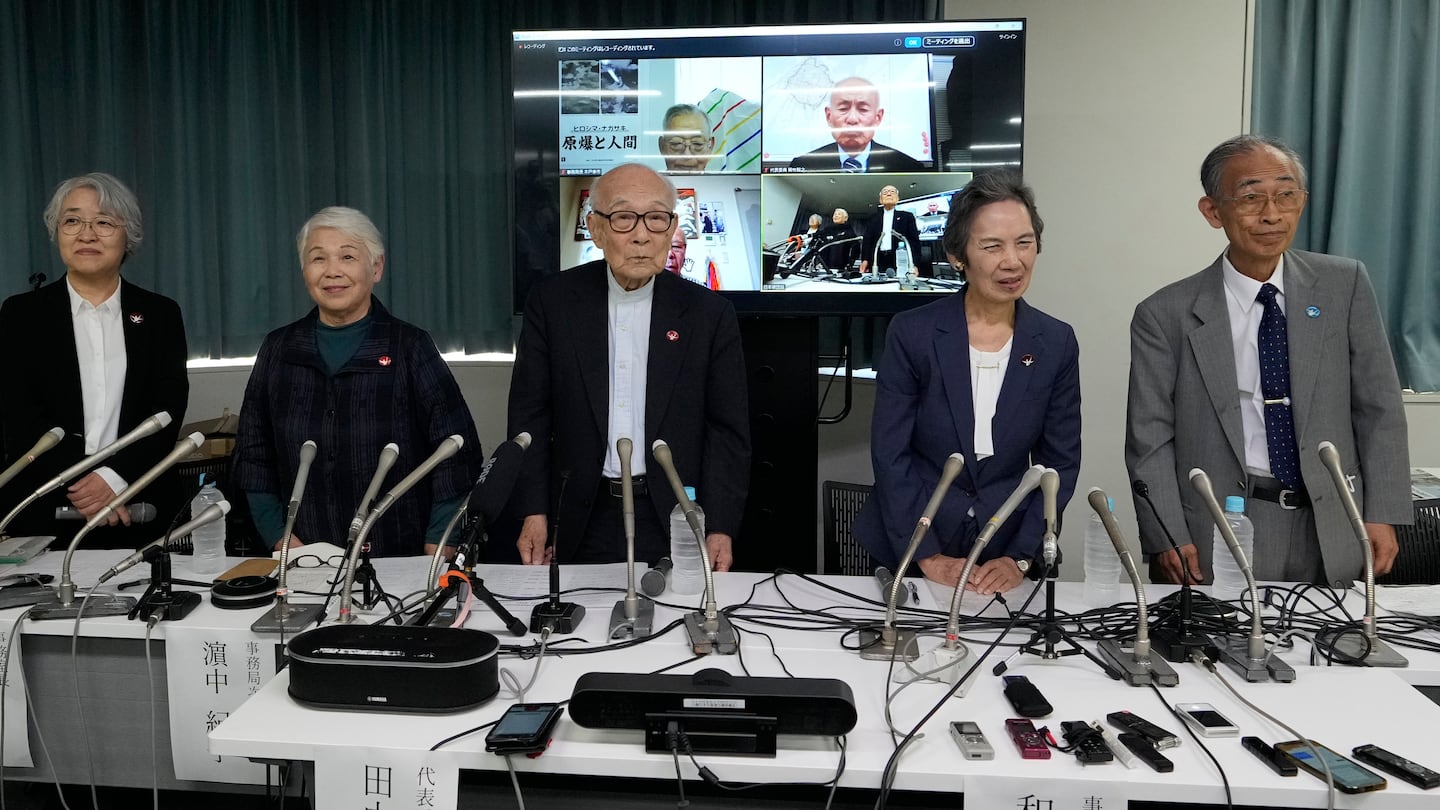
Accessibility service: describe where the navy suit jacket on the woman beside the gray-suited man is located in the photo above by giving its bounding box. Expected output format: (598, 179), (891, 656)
(855, 293), (1080, 566)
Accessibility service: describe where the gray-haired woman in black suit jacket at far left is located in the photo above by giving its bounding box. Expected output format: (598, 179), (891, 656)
(0, 173), (190, 548)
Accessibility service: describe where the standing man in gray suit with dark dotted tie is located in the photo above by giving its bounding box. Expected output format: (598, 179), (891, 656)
(1125, 135), (1413, 587)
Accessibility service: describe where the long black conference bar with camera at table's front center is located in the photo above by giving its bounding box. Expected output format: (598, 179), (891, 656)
(570, 669), (855, 736)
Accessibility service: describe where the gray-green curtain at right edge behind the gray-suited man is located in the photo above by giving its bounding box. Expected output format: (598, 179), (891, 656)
(1251, 0), (1440, 391)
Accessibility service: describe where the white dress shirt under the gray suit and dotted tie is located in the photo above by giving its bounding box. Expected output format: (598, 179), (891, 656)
(1221, 257), (1284, 477)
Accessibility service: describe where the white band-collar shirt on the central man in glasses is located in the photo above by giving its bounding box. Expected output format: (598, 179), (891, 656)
(602, 272), (655, 479)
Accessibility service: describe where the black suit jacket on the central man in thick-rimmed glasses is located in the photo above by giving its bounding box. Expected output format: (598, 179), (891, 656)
(507, 259), (750, 561)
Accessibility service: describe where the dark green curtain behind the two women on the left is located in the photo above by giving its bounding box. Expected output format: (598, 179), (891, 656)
(0, 0), (939, 357)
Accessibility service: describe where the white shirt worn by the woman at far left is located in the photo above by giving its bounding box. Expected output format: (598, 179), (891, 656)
(65, 278), (127, 494)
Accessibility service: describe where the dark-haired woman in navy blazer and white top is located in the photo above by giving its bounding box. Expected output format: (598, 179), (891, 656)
(855, 173), (1080, 594)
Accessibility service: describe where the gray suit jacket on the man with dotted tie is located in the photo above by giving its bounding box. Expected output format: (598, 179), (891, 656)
(1125, 251), (1413, 585)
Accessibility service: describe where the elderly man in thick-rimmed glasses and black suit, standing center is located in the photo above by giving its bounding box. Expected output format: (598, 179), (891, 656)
(508, 163), (750, 571)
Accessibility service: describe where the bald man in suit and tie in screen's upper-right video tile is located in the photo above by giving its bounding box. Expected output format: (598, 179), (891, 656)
(791, 76), (924, 173)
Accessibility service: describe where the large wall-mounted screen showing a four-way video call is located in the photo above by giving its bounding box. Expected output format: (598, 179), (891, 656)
(513, 20), (1025, 314)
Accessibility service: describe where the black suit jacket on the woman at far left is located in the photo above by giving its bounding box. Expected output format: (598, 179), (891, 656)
(0, 278), (190, 548)
